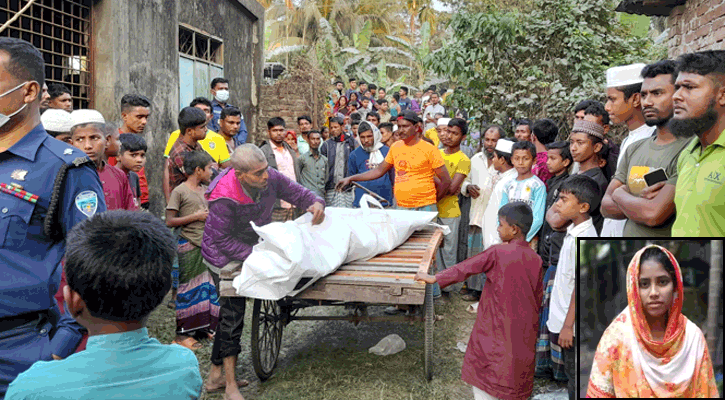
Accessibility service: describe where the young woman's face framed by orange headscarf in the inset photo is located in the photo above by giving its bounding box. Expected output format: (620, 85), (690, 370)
(639, 259), (675, 318)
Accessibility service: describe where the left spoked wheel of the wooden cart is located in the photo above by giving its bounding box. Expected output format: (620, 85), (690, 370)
(252, 299), (284, 382)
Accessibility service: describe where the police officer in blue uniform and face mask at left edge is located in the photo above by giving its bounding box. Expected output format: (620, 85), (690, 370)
(0, 37), (106, 399)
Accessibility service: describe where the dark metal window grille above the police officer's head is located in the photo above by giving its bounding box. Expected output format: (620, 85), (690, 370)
(0, 0), (92, 109)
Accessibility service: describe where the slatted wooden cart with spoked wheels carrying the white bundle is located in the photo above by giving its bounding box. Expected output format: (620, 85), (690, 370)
(219, 228), (443, 381)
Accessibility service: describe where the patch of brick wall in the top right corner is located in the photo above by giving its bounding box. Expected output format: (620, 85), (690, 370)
(667, 0), (725, 57)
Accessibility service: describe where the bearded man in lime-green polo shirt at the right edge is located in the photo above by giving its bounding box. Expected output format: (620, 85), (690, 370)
(668, 50), (725, 236)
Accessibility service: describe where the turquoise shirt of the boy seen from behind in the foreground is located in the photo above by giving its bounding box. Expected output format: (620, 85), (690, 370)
(5, 328), (202, 400)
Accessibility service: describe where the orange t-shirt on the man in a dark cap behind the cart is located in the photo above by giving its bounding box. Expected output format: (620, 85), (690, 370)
(385, 140), (445, 208)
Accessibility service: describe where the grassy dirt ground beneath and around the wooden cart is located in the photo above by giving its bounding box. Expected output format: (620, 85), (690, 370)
(149, 294), (566, 400)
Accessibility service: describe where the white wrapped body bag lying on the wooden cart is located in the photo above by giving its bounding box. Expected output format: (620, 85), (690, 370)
(232, 195), (437, 300)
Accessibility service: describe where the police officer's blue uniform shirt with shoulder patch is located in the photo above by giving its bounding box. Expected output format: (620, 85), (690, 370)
(0, 125), (106, 357)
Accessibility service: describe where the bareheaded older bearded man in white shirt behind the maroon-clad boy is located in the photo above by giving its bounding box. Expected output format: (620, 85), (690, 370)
(461, 125), (504, 301)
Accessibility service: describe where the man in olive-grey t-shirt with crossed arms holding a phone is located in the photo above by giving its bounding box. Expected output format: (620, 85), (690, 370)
(601, 60), (689, 237)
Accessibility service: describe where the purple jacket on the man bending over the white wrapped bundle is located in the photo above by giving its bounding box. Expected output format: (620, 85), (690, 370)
(201, 168), (325, 268)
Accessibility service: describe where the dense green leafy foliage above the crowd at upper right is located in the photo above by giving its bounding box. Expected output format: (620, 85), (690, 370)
(425, 0), (663, 135)
